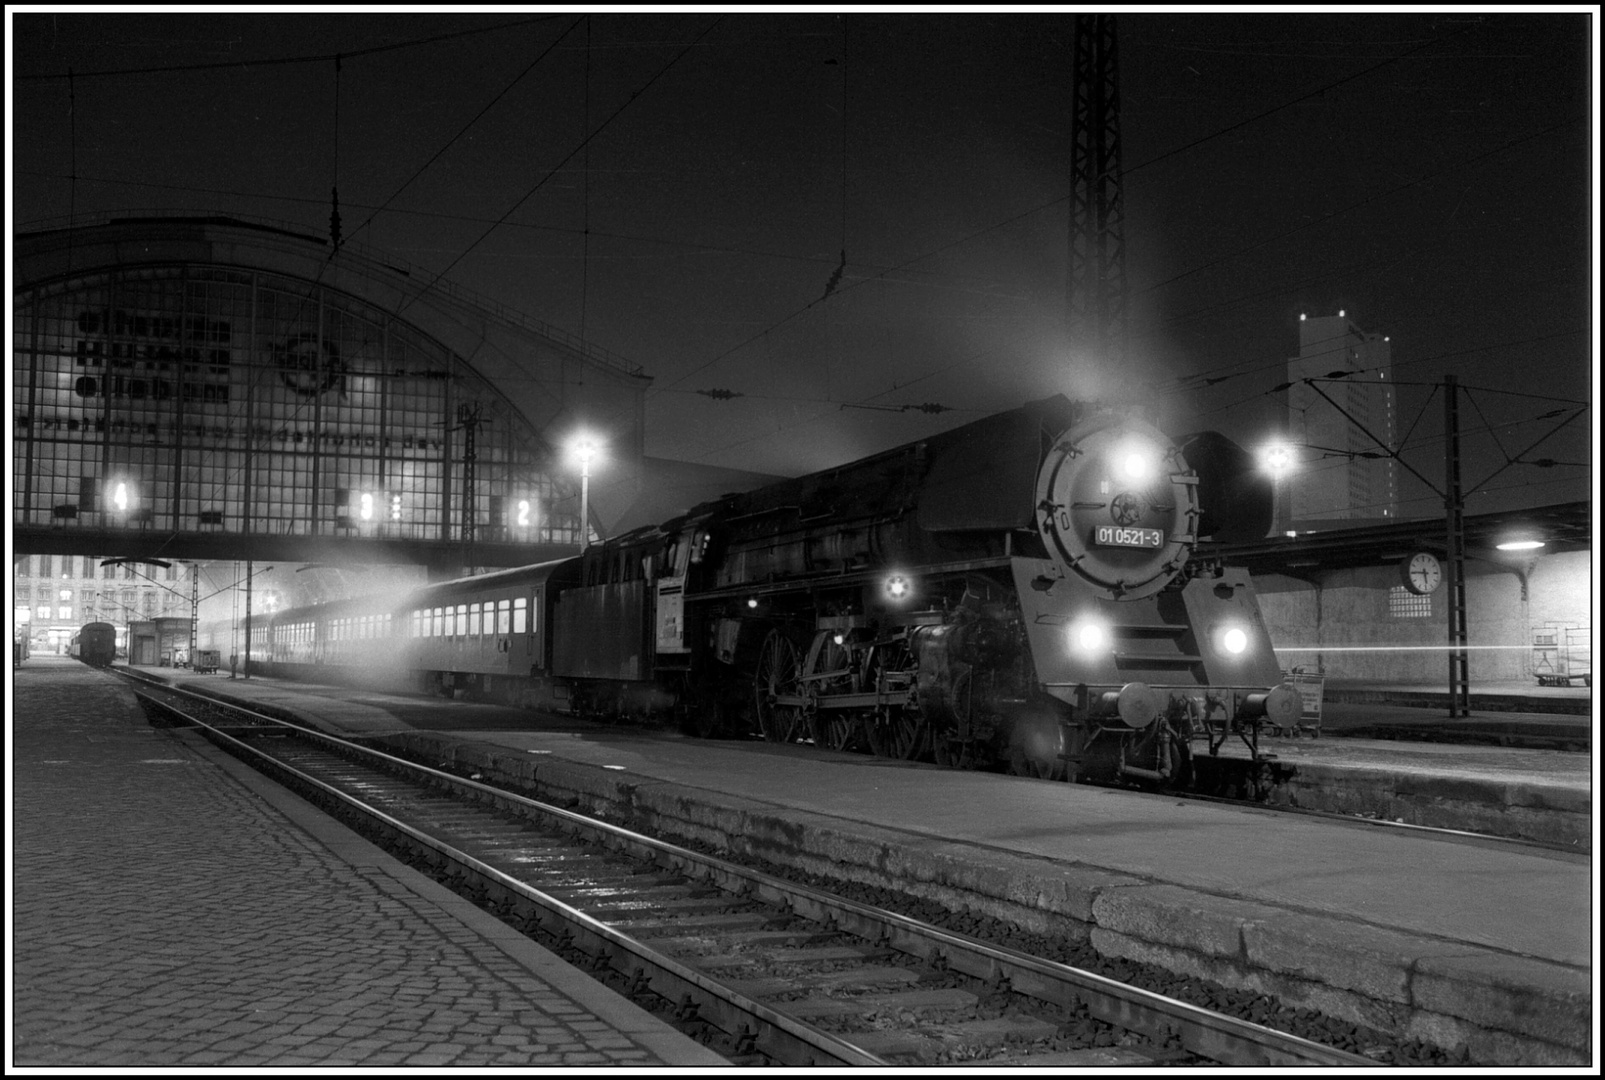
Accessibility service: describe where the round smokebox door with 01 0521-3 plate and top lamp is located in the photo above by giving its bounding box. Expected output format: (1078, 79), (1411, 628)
(1037, 417), (1199, 600)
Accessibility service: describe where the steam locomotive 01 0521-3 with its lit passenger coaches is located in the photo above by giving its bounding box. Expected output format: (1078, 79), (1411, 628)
(210, 395), (1300, 786)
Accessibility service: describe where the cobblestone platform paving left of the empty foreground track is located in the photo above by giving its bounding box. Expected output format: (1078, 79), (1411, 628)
(11, 658), (725, 1069)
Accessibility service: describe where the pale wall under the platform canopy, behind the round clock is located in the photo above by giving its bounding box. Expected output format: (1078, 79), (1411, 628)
(1255, 552), (1595, 684)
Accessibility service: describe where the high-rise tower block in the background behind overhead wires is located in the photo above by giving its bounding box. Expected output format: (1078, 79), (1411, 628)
(1282, 311), (1398, 522)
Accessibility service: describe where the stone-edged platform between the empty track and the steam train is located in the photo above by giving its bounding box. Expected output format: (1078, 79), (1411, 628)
(109, 671), (1597, 1066)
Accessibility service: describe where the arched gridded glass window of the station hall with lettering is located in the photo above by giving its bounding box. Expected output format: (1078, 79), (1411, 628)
(11, 265), (579, 544)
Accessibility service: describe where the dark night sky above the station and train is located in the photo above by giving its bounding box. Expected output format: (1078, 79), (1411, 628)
(8, 8), (1599, 517)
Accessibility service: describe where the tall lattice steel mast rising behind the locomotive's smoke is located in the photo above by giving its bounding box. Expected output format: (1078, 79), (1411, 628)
(1067, 14), (1127, 366)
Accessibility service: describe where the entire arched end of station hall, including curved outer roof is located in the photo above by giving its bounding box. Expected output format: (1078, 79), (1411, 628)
(11, 217), (648, 577)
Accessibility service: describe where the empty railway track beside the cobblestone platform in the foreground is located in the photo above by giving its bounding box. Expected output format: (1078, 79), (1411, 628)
(136, 687), (1392, 1067)
